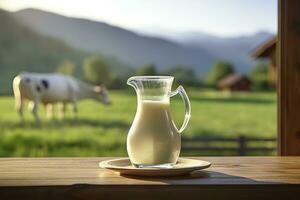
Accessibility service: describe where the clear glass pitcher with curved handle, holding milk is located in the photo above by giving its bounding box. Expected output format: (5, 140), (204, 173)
(127, 76), (191, 168)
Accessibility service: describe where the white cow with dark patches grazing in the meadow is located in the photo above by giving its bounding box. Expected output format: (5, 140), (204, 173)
(13, 73), (111, 122)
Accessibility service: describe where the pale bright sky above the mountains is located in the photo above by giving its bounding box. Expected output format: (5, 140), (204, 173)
(0, 0), (277, 37)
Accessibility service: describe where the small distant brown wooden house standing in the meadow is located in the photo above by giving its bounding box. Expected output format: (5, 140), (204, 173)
(218, 74), (251, 91)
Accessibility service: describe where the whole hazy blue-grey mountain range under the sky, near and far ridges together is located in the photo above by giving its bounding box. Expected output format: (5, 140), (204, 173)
(0, 9), (272, 79)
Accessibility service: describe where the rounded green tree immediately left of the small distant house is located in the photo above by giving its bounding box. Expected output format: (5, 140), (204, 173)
(207, 61), (234, 86)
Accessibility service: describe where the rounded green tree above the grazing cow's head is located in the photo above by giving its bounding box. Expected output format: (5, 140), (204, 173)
(83, 56), (113, 85)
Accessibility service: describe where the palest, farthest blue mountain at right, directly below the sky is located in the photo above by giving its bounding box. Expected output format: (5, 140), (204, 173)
(165, 32), (274, 73)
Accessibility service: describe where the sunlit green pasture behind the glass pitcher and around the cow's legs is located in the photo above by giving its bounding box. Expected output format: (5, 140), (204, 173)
(0, 89), (276, 156)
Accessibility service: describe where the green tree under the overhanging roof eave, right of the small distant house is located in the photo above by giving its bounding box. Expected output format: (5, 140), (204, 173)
(250, 62), (270, 90)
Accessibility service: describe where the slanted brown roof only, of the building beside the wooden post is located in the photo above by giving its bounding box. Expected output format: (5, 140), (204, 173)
(250, 36), (277, 59)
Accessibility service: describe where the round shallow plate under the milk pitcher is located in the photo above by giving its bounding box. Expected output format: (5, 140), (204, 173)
(99, 158), (211, 176)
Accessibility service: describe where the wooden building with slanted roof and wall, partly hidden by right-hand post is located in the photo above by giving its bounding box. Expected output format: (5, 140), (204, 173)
(250, 36), (277, 86)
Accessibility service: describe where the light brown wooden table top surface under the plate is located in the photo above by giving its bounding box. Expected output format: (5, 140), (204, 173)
(0, 157), (300, 187)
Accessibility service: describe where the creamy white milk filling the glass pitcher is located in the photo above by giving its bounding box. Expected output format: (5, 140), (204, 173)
(127, 100), (181, 166)
